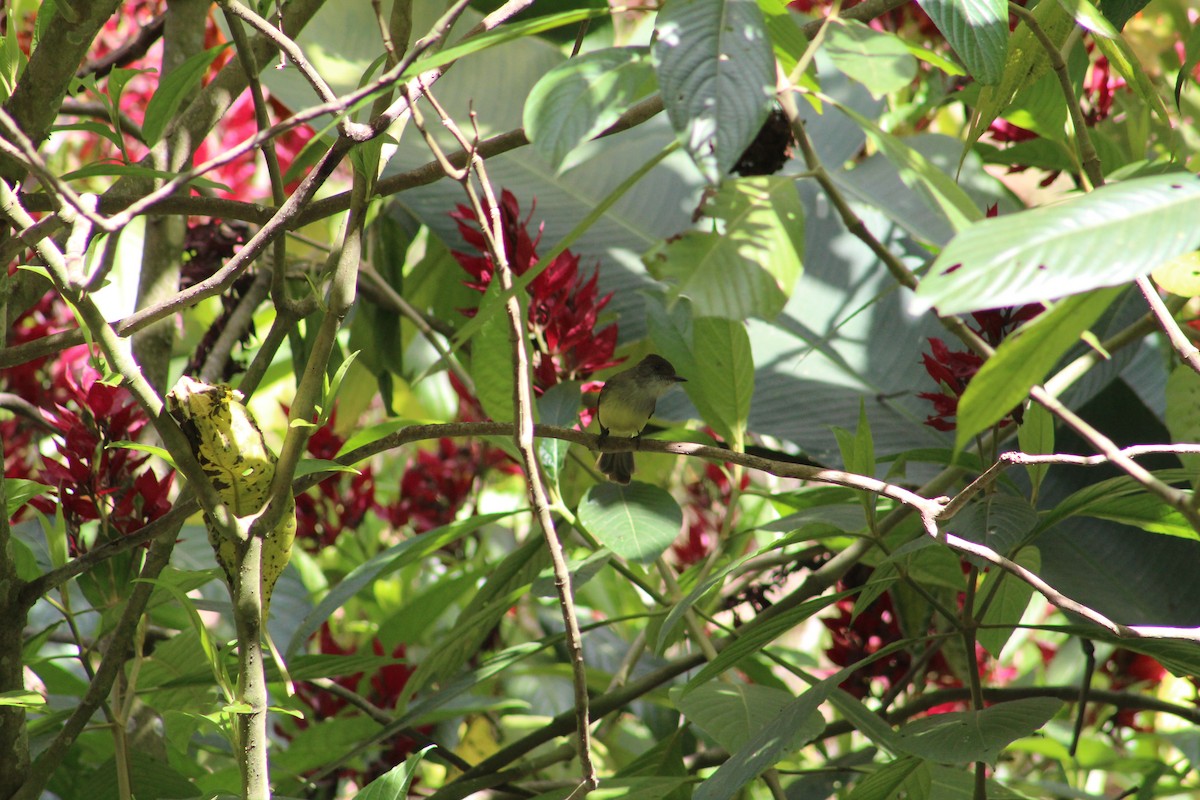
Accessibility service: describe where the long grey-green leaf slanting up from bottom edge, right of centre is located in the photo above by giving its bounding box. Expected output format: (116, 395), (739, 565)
(692, 670), (845, 800)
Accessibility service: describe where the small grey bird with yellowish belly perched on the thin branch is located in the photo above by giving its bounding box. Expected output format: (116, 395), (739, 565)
(596, 355), (686, 483)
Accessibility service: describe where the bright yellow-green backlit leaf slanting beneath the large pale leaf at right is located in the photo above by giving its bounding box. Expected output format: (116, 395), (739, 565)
(954, 287), (1124, 450)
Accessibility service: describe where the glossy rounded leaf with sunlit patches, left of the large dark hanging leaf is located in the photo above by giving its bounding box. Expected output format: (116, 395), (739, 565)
(523, 47), (654, 172)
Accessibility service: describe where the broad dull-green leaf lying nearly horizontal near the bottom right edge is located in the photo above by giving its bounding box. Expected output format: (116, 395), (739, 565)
(900, 697), (1062, 764)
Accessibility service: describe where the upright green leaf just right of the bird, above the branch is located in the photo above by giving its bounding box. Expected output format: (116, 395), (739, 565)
(683, 317), (754, 450)
